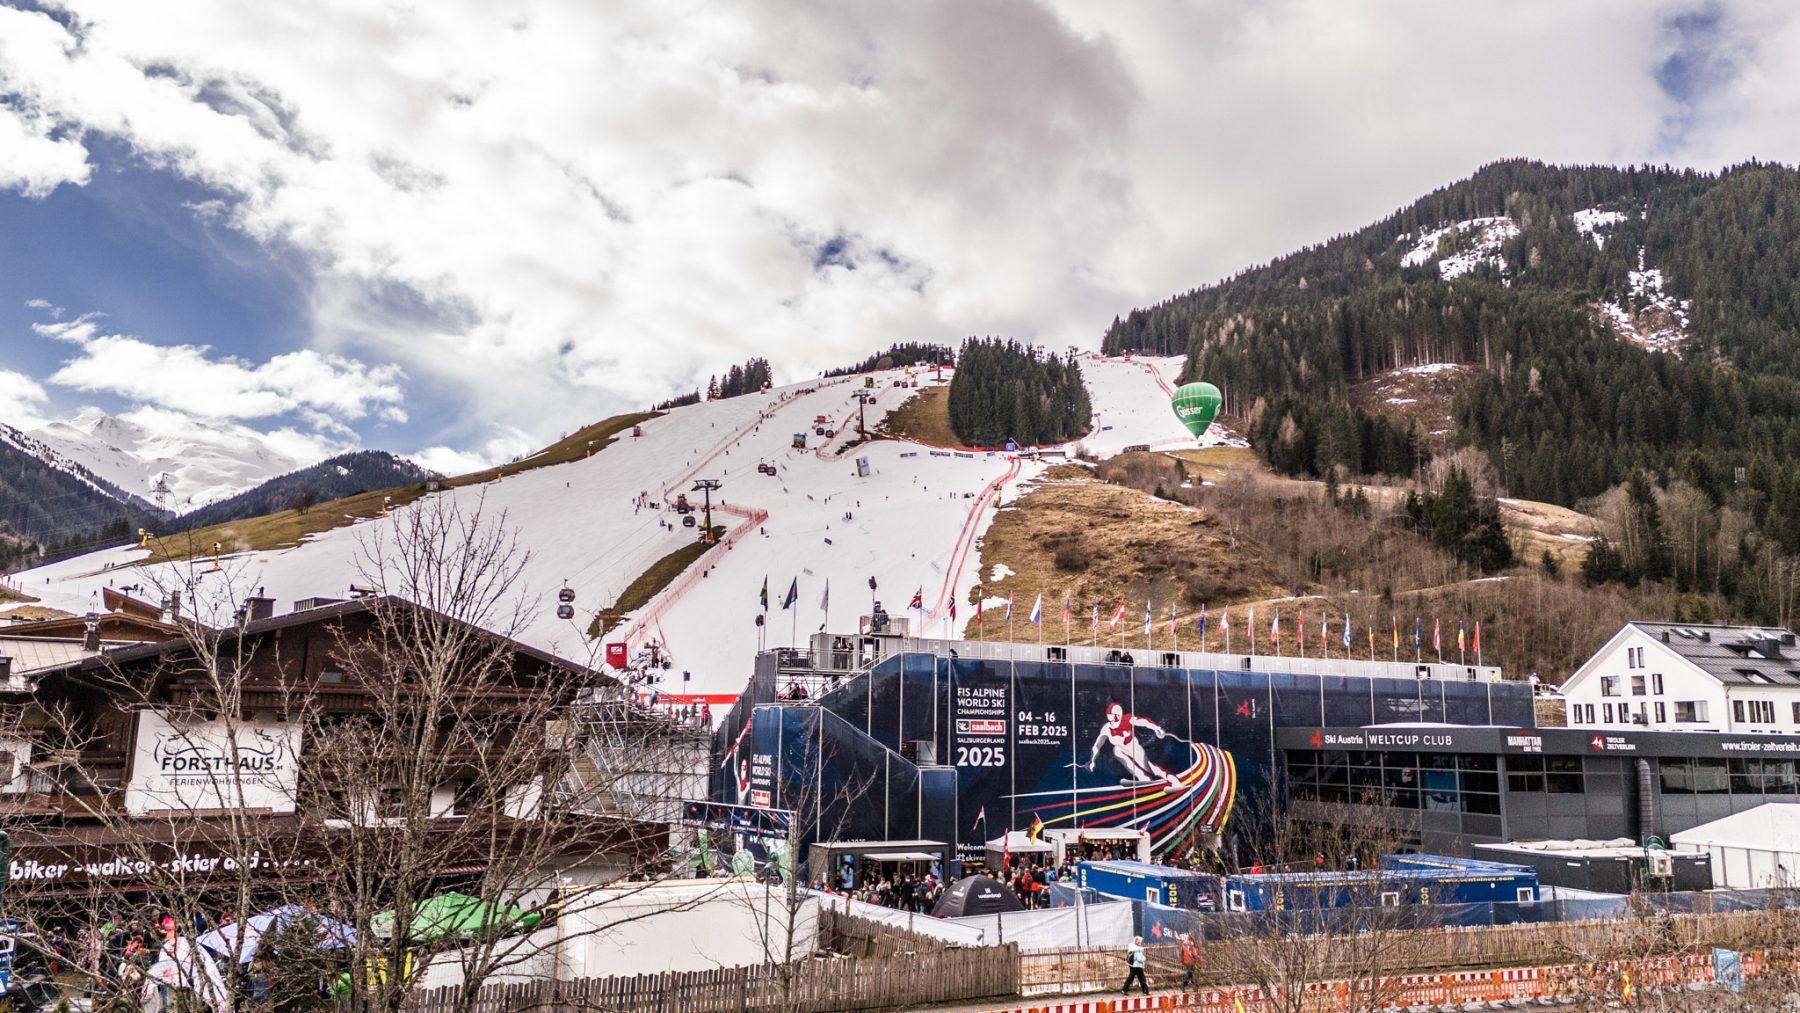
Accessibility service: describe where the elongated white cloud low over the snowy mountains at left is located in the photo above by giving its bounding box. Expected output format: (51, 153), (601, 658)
(32, 315), (403, 432)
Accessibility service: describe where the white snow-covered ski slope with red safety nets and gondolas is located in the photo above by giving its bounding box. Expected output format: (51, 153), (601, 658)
(18, 356), (1219, 695)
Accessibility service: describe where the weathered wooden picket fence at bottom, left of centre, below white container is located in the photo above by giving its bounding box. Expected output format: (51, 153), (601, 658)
(407, 946), (1019, 1013)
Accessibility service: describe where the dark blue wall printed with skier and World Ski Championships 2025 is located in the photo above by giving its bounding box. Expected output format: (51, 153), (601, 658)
(718, 653), (1530, 856)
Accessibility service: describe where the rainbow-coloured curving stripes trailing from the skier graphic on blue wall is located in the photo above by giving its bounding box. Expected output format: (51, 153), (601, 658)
(1012, 743), (1237, 855)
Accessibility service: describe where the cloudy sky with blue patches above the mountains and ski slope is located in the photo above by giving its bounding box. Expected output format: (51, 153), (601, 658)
(0, 0), (1800, 470)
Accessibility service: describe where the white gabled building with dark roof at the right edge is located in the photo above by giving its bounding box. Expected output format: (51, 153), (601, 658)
(1562, 623), (1800, 734)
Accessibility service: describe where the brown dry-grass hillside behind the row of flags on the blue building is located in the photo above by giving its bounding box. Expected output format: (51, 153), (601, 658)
(967, 448), (1684, 682)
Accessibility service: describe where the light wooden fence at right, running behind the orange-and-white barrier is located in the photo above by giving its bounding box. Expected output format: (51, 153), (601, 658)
(1019, 910), (1800, 995)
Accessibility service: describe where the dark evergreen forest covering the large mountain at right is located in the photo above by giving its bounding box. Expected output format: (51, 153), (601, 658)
(1105, 160), (1800, 623)
